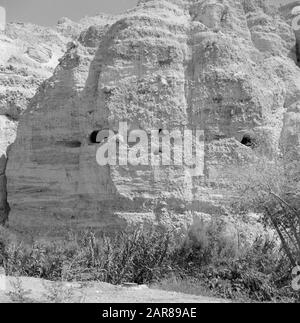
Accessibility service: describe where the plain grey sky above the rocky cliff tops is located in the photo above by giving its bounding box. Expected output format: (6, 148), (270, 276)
(0, 0), (293, 26)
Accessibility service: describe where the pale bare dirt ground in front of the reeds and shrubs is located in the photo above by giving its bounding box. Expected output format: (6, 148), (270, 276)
(0, 277), (227, 303)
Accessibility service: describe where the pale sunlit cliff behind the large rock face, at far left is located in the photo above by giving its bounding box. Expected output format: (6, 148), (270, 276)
(0, 15), (116, 222)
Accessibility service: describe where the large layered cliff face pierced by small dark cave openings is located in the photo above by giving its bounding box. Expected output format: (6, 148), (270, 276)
(0, 0), (300, 235)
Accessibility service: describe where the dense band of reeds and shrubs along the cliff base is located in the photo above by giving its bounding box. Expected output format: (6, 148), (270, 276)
(1, 218), (297, 302)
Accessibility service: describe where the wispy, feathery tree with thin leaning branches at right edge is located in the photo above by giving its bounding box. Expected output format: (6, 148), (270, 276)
(227, 159), (300, 267)
